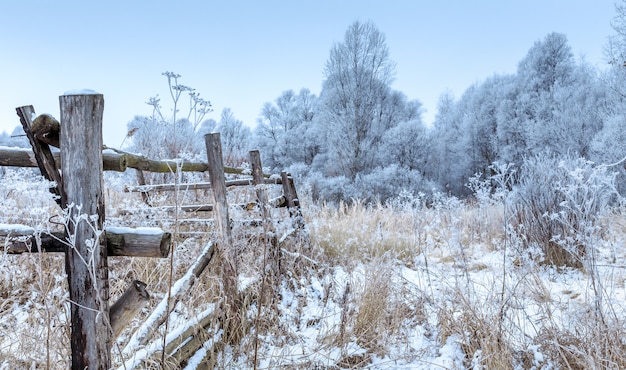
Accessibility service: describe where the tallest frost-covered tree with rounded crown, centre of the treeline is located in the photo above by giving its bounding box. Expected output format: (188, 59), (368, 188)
(320, 21), (398, 179)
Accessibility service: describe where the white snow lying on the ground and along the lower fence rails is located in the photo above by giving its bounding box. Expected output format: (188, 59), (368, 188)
(0, 168), (626, 370)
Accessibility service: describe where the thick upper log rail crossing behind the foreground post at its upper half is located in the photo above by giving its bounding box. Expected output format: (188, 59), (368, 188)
(0, 146), (126, 172)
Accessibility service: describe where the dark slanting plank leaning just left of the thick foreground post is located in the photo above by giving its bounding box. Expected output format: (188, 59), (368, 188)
(16, 105), (63, 205)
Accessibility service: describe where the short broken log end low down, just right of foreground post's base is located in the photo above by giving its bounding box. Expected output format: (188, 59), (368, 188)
(109, 280), (150, 338)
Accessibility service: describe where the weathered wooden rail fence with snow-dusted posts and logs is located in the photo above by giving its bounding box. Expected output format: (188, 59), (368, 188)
(0, 97), (302, 369)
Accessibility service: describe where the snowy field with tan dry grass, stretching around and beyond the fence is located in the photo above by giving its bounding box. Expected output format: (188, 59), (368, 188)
(0, 166), (626, 369)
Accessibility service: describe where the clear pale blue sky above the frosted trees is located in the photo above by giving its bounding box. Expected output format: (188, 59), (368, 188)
(0, 0), (615, 147)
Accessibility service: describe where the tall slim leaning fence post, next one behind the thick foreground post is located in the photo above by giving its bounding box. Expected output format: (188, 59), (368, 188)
(204, 132), (240, 339)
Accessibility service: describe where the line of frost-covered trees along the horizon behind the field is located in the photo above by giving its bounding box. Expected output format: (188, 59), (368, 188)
(7, 11), (626, 201)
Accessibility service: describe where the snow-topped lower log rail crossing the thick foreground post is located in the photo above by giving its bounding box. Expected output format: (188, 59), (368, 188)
(0, 224), (172, 258)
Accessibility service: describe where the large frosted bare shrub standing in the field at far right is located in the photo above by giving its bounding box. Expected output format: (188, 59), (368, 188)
(508, 153), (618, 267)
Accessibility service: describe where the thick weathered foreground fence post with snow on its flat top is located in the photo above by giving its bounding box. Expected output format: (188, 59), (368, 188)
(59, 92), (111, 370)
